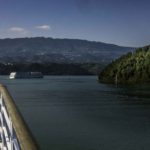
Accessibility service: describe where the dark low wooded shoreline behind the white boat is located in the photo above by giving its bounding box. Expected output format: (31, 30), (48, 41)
(0, 63), (102, 75)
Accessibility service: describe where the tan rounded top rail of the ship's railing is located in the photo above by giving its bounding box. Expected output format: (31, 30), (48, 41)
(0, 84), (39, 150)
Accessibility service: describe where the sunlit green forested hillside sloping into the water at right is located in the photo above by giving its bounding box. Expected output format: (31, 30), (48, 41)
(99, 46), (150, 84)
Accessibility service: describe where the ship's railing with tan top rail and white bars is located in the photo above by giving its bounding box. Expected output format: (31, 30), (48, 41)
(0, 84), (39, 150)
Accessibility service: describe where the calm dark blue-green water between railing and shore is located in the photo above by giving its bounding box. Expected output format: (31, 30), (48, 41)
(0, 76), (150, 150)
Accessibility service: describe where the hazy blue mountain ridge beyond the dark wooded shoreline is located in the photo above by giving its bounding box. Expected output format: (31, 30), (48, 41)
(0, 37), (134, 64)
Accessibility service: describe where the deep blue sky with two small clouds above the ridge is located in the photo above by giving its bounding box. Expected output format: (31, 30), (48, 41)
(0, 0), (150, 47)
